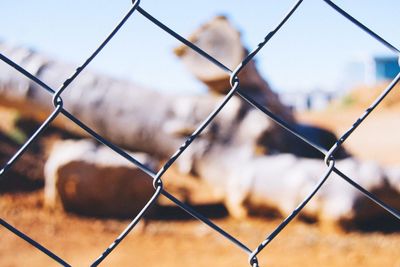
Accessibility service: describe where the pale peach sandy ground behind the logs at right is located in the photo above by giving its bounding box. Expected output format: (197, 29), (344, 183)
(298, 107), (400, 165)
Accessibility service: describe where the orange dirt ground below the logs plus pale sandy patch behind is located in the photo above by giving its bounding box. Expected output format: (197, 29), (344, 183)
(0, 105), (400, 267)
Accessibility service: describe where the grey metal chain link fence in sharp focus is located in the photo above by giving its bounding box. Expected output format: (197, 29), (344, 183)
(0, 0), (400, 267)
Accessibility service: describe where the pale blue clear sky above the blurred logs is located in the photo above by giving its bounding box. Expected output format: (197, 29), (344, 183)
(0, 0), (400, 93)
